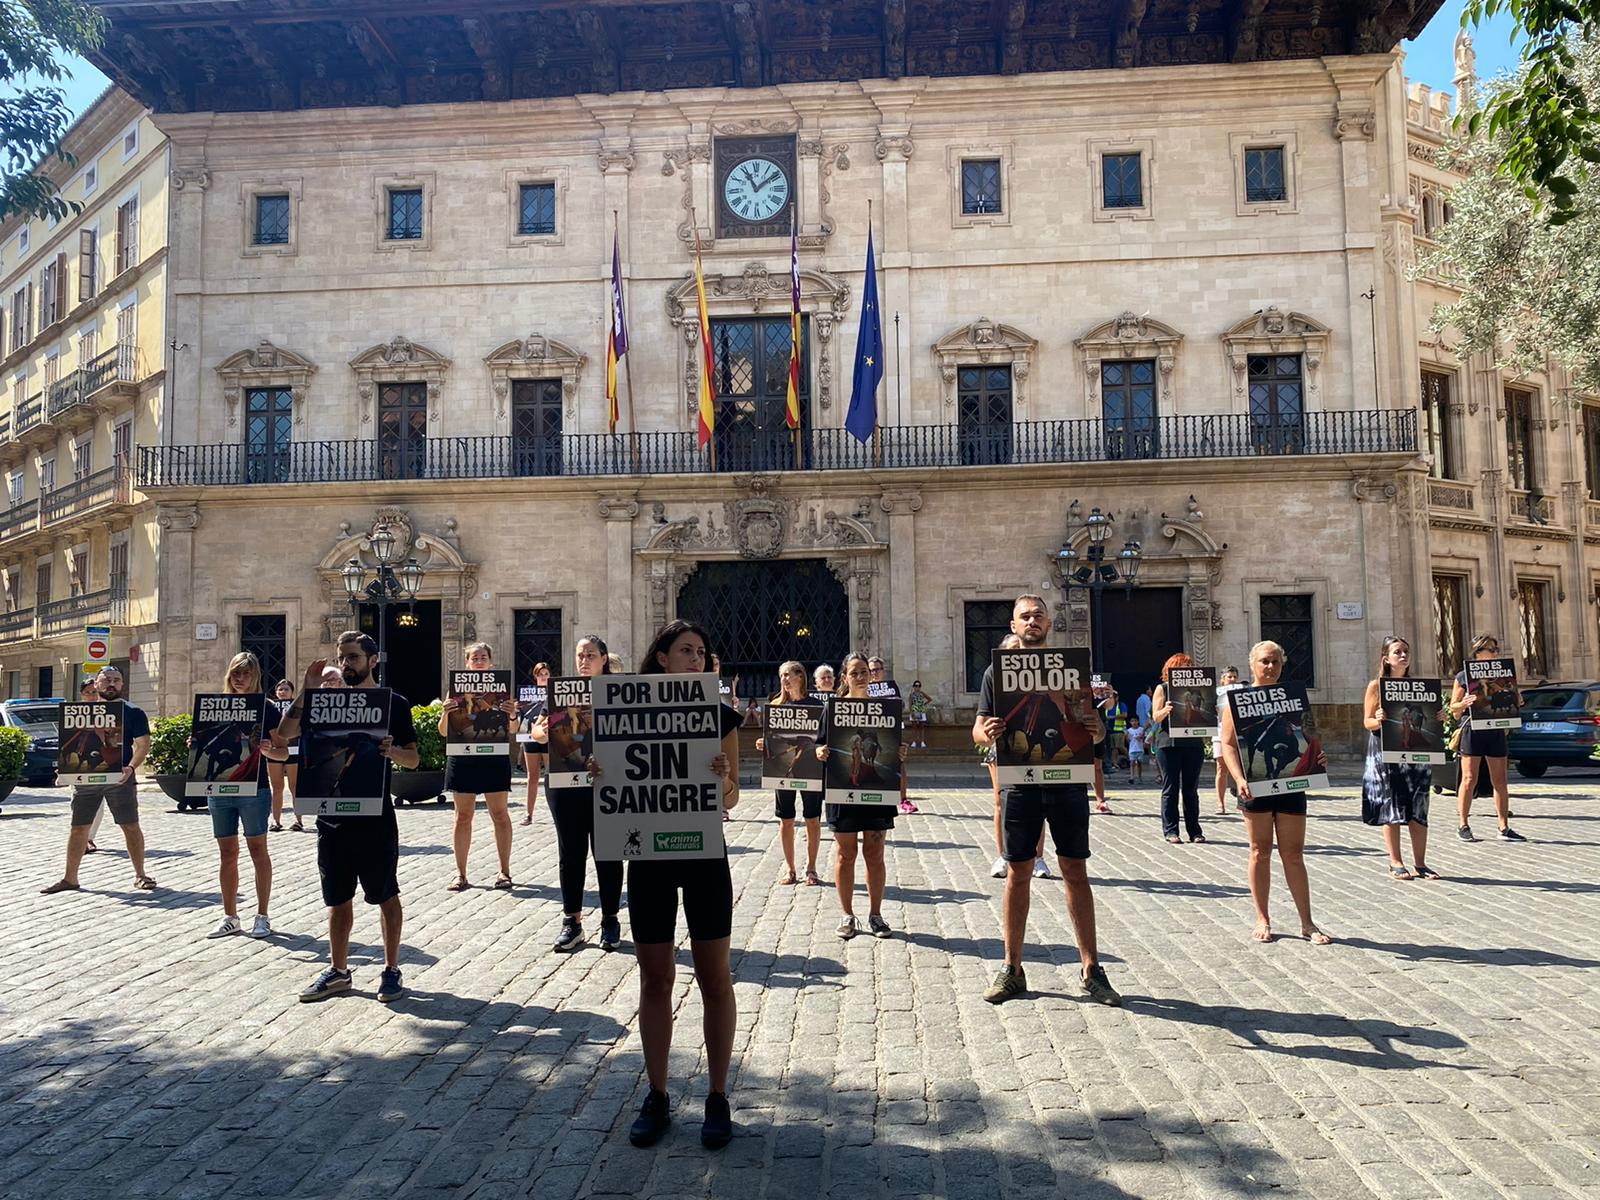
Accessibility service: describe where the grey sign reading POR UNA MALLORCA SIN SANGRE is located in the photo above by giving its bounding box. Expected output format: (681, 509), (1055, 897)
(592, 675), (726, 862)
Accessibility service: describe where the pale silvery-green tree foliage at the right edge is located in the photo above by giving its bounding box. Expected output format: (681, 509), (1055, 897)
(1416, 38), (1600, 394)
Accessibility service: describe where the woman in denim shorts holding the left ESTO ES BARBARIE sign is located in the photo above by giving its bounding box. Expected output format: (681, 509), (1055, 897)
(189, 650), (288, 938)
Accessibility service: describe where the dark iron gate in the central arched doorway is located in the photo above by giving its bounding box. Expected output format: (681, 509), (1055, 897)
(678, 558), (850, 699)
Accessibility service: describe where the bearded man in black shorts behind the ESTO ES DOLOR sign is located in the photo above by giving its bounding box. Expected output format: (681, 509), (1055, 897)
(973, 595), (1122, 1005)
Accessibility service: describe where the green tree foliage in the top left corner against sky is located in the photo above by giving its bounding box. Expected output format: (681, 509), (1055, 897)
(0, 0), (106, 221)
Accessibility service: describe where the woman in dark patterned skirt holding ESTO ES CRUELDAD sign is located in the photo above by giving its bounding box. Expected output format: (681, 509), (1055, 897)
(1362, 635), (1445, 880)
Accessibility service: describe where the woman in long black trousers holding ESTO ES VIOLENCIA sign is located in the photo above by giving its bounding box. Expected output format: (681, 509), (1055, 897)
(528, 634), (622, 954)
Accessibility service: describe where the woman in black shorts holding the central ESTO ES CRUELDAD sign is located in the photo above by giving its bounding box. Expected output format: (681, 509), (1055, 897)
(816, 651), (906, 939)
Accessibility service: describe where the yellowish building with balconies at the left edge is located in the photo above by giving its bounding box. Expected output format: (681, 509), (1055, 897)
(0, 90), (171, 710)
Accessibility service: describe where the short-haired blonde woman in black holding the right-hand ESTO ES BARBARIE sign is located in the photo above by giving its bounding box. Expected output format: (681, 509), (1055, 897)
(1218, 642), (1333, 946)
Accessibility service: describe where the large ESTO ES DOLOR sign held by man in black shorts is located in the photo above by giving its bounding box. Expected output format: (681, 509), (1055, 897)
(990, 650), (1098, 784)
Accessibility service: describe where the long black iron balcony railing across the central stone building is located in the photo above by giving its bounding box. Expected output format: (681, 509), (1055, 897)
(138, 410), (1416, 490)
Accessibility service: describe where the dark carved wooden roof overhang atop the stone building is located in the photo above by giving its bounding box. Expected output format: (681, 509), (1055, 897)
(90, 0), (1442, 112)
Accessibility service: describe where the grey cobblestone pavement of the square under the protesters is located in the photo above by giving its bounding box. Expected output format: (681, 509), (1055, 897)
(0, 776), (1600, 1200)
